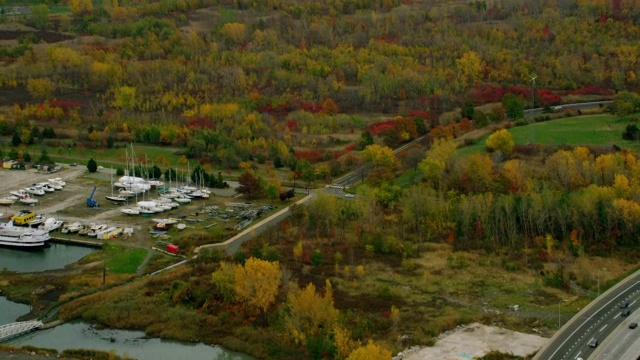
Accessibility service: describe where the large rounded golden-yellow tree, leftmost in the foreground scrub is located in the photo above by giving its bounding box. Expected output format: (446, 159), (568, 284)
(233, 257), (281, 317)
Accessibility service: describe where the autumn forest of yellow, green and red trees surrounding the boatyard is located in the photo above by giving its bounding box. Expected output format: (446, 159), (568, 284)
(0, 0), (640, 360)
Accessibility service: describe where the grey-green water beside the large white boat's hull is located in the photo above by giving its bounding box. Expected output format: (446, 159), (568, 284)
(0, 242), (96, 272)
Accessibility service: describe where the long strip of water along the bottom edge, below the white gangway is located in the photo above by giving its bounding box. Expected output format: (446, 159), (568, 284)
(4, 322), (253, 360)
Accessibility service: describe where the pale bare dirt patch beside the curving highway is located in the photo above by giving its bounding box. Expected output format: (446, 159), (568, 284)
(403, 323), (549, 360)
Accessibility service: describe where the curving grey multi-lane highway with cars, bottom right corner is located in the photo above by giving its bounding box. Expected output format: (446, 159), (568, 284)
(533, 271), (640, 360)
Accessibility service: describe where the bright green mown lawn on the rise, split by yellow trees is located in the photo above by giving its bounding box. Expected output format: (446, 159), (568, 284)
(456, 114), (640, 156)
